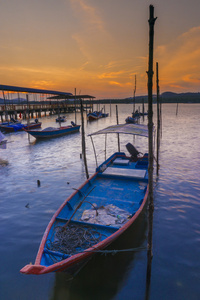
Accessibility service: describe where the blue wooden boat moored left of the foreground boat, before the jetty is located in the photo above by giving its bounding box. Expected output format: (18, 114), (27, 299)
(24, 125), (80, 139)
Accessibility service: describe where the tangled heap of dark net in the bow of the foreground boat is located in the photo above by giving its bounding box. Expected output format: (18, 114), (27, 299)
(47, 224), (102, 255)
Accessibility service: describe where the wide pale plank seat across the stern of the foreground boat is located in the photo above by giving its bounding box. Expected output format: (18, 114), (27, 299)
(103, 167), (146, 179)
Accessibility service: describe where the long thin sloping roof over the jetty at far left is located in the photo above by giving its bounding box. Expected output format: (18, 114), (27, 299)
(0, 85), (72, 96)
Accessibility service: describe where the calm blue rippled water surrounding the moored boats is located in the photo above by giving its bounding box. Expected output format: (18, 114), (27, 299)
(0, 104), (200, 300)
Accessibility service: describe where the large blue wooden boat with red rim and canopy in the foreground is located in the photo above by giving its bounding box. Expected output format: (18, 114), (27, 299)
(20, 124), (148, 275)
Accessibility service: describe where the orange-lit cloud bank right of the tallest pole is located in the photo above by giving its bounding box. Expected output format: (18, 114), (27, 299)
(155, 27), (200, 92)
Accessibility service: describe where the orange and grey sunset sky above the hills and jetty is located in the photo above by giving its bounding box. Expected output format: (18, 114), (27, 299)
(0, 0), (200, 99)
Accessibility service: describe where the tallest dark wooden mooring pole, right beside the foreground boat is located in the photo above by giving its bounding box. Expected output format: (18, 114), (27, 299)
(146, 5), (156, 294)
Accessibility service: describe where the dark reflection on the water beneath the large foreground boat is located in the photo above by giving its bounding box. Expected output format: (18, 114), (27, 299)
(51, 211), (147, 300)
